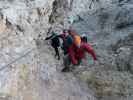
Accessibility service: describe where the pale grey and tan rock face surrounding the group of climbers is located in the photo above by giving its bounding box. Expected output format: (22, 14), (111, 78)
(0, 0), (133, 100)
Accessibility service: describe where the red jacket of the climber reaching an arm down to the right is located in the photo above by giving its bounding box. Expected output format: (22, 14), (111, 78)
(68, 43), (96, 65)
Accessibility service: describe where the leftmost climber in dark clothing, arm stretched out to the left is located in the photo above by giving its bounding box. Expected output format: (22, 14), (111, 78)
(45, 31), (60, 60)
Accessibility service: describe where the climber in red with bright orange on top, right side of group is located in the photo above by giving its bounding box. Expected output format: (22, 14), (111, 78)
(62, 31), (96, 72)
